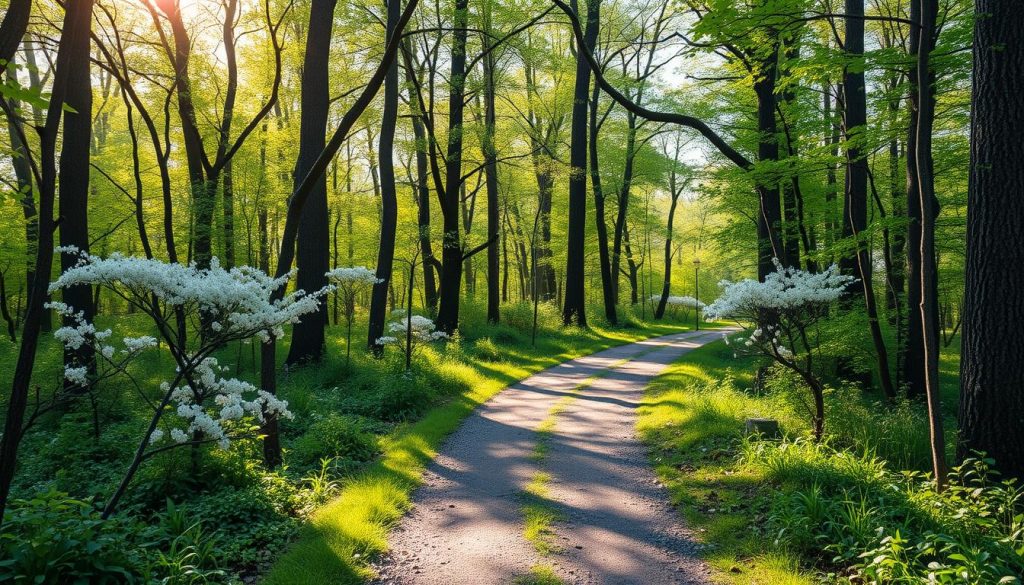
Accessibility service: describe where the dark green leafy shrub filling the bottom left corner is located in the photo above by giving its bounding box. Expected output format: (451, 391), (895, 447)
(0, 490), (142, 584)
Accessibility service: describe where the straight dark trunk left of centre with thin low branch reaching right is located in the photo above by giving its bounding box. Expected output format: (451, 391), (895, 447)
(437, 0), (469, 333)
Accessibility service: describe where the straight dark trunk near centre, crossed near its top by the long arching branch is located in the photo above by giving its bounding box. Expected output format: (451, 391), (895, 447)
(562, 0), (601, 327)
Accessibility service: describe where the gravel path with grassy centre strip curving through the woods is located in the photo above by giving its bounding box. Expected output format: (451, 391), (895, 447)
(377, 330), (722, 585)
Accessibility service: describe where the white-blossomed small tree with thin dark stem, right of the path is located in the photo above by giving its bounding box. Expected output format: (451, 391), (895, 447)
(705, 259), (855, 440)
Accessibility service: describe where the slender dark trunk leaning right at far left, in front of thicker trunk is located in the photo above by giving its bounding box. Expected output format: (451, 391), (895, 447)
(0, 0), (92, 524)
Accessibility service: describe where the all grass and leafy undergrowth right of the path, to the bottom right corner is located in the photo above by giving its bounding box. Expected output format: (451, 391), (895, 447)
(638, 336), (1024, 585)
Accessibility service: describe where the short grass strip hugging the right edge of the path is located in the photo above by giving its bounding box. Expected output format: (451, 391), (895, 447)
(637, 336), (812, 585)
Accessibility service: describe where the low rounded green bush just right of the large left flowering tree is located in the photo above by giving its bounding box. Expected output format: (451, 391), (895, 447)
(290, 414), (380, 467)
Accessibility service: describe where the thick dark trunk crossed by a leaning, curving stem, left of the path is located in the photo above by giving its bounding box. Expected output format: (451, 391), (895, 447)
(287, 0), (337, 364)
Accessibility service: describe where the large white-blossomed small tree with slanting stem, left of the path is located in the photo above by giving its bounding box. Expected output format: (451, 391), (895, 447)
(49, 249), (328, 515)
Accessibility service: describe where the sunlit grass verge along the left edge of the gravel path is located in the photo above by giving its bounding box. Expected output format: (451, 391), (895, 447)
(263, 317), (682, 585)
